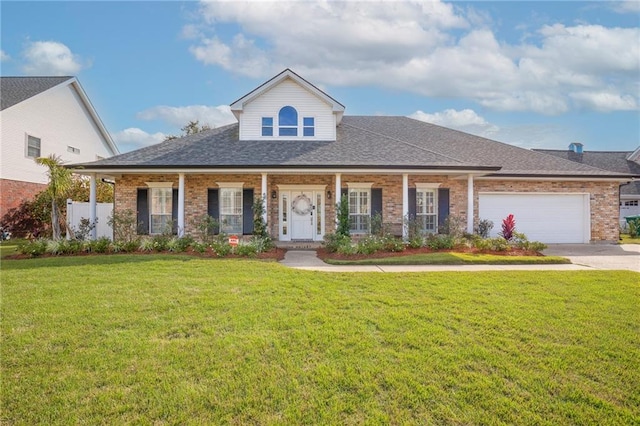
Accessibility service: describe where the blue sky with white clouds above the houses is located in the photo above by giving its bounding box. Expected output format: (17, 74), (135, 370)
(0, 0), (640, 152)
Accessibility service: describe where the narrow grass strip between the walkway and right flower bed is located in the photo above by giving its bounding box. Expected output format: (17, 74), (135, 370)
(324, 252), (571, 265)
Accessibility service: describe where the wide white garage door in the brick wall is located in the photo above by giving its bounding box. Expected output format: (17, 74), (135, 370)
(478, 193), (591, 243)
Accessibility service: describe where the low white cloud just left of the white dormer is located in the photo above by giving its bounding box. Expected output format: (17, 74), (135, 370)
(137, 105), (237, 129)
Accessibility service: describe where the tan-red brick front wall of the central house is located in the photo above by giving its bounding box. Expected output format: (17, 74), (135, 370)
(115, 173), (619, 241)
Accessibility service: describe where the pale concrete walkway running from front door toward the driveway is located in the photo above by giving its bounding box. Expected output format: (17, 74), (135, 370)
(280, 250), (593, 272)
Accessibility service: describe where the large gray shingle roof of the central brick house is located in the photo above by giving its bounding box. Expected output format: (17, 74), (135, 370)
(74, 116), (636, 177)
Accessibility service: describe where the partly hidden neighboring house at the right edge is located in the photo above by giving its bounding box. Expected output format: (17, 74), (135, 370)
(534, 142), (640, 227)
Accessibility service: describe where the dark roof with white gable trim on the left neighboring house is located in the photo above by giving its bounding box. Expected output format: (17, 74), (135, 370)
(0, 76), (120, 155)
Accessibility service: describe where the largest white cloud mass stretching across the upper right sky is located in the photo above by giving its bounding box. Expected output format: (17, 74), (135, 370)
(184, 0), (640, 114)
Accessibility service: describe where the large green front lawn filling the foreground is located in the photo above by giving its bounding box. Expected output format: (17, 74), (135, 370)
(0, 255), (640, 425)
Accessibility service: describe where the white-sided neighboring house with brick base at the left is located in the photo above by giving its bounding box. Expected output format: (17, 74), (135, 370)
(0, 77), (119, 218)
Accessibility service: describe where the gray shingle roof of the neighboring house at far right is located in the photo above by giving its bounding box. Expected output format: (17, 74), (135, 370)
(536, 149), (640, 195)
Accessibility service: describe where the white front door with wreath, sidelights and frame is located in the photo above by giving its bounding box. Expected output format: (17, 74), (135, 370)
(278, 185), (325, 241)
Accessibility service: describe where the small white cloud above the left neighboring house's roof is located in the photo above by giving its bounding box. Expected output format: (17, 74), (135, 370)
(22, 41), (87, 75)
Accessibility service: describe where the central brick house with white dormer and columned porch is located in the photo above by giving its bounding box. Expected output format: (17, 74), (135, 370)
(72, 69), (631, 243)
